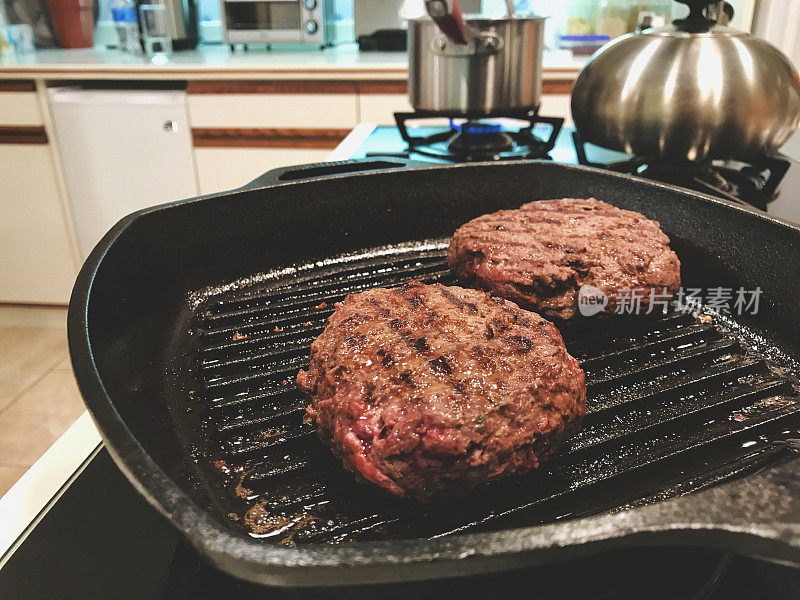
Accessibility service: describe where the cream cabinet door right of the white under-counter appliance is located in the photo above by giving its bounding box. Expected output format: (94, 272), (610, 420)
(194, 148), (331, 194)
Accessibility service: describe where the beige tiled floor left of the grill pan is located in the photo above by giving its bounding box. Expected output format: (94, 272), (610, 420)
(0, 307), (84, 496)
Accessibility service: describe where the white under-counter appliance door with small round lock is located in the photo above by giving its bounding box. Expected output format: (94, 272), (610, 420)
(49, 88), (198, 258)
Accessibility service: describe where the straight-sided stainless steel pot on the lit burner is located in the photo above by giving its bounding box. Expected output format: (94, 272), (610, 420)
(408, 16), (545, 115)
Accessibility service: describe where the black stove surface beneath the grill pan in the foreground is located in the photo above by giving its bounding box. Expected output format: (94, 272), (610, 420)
(0, 449), (800, 600)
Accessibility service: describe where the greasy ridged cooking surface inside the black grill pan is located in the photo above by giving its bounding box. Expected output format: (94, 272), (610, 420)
(184, 243), (800, 544)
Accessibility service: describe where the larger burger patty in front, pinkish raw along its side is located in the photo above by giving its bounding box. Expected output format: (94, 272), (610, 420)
(297, 281), (586, 501)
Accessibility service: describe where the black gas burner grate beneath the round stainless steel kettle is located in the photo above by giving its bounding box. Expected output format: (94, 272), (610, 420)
(572, 131), (791, 210)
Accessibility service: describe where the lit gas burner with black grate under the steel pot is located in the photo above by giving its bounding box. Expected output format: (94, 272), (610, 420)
(394, 111), (564, 162)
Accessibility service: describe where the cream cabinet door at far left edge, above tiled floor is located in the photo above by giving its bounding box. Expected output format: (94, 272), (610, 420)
(0, 144), (76, 304)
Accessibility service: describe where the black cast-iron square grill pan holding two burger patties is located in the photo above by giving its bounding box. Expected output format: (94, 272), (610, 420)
(69, 159), (800, 587)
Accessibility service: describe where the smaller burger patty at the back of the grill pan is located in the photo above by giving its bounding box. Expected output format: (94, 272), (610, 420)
(447, 198), (681, 319)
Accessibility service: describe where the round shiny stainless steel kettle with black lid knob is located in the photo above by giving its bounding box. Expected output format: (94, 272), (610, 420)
(572, 0), (800, 161)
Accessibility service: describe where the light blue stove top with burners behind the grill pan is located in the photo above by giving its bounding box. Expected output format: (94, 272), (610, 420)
(360, 120), (792, 210)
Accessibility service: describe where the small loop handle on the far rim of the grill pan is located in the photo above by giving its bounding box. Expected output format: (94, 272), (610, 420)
(241, 157), (433, 190)
